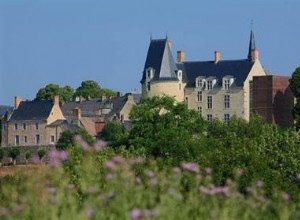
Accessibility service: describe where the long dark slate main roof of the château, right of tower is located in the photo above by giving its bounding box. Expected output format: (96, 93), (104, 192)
(177, 59), (254, 87)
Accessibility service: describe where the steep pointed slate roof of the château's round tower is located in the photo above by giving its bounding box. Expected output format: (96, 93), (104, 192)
(141, 39), (178, 83)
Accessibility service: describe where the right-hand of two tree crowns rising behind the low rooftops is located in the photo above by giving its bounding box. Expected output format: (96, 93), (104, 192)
(73, 80), (116, 99)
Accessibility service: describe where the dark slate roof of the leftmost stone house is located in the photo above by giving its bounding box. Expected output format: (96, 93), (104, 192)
(10, 100), (54, 120)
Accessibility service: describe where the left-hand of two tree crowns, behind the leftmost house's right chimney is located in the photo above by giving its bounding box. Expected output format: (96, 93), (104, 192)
(36, 84), (74, 102)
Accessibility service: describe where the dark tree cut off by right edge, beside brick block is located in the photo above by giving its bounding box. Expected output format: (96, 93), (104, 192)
(290, 67), (300, 130)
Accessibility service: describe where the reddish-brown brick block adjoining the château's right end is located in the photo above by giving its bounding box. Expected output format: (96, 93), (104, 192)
(252, 75), (295, 127)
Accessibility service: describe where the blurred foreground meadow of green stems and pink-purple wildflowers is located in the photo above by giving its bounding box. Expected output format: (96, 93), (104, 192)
(0, 140), (300, 220)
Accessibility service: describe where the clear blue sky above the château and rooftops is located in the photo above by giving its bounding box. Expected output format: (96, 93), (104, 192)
(0, 0), (300, 104)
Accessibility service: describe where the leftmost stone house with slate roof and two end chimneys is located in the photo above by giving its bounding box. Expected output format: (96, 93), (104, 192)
(2, 96), (65, 147)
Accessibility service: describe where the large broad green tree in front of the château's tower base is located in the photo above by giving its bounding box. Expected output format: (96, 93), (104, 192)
(129, 96), (206, 161)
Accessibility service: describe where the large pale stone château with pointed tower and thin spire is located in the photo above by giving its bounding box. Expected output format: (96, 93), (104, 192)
(141, 31), (267, 121)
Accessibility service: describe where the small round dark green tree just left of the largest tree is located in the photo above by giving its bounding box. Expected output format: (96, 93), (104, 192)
(99, 121), (128, 146)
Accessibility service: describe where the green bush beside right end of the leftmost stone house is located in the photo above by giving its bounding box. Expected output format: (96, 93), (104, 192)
(56, 129), (95, 150)
